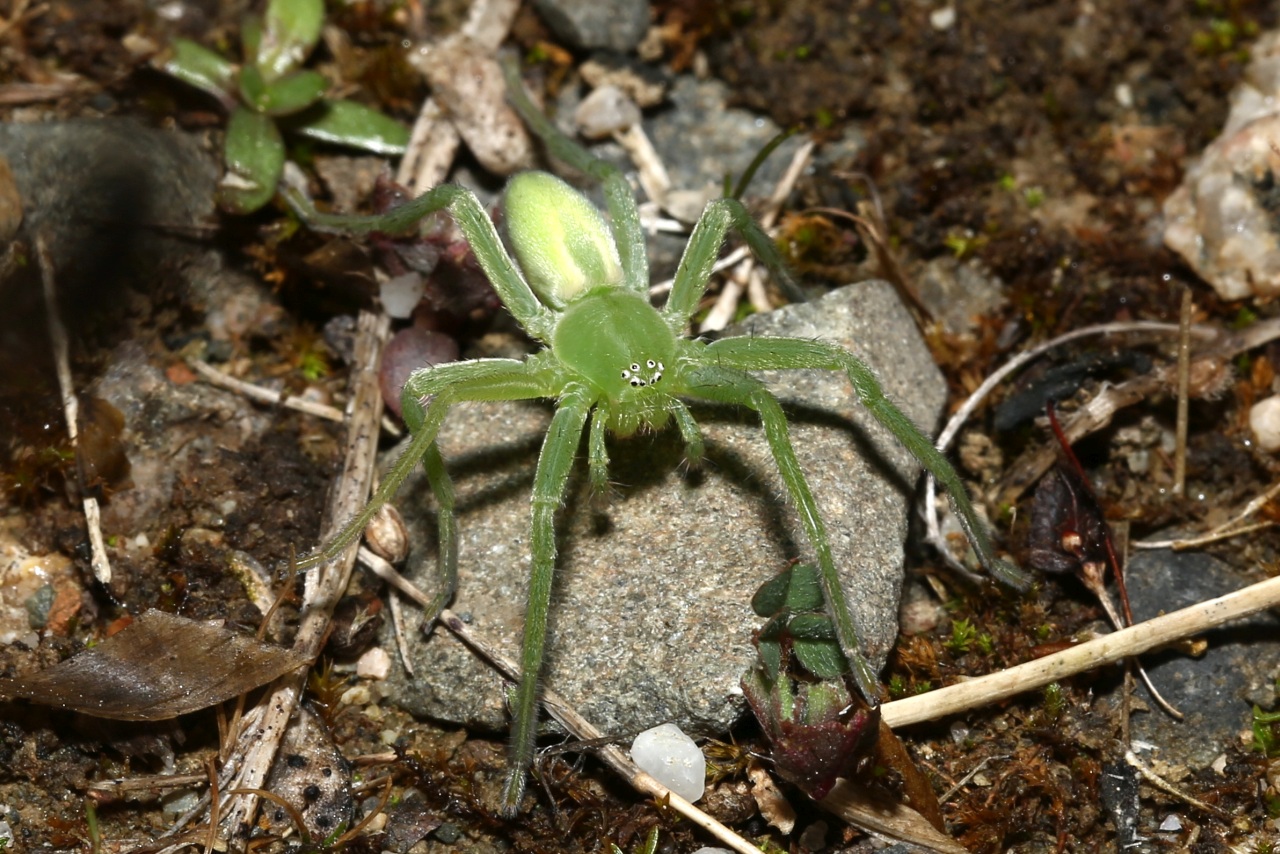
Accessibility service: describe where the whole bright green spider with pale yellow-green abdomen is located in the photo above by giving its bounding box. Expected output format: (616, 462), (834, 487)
(289, 65), (1028, 814)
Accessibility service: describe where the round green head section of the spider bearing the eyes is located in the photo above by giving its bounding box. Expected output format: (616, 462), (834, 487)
(552, 288), (676, 401)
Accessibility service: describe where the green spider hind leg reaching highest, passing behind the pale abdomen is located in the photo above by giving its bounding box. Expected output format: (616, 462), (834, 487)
(502, 61), (649, 294)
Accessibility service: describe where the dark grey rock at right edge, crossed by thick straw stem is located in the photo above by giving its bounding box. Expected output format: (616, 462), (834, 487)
(1105, 551), (1280, 769)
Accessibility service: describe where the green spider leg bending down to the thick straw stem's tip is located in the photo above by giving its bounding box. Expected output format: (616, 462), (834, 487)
(687, 363), (881, 705)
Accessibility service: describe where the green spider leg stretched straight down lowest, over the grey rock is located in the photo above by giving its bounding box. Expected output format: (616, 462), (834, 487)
(502, 383), (595, 816)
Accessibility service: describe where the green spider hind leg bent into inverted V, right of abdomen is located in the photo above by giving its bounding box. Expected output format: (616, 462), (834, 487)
(662, 198), (804, 334)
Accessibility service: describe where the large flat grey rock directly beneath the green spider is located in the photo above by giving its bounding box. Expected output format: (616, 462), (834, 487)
(373, 282), (945, 732)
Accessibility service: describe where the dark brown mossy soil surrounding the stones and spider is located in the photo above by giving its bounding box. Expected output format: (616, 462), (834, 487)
(0, 0), (1280, 851)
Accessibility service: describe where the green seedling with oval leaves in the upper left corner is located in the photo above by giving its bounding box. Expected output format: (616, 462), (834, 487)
(160, 0), (408, 214)
